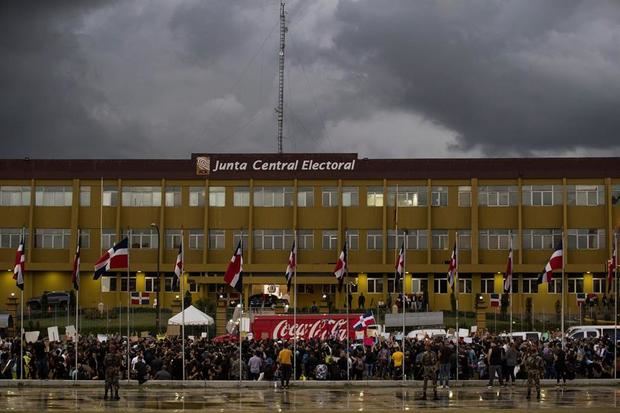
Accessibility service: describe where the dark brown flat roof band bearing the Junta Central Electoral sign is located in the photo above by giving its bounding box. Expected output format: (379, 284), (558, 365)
(0, 153), (620, 180)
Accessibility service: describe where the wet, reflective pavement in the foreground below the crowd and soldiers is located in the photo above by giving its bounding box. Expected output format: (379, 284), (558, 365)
(0, 386), (620, 413)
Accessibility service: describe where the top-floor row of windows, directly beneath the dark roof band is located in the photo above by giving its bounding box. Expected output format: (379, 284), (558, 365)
(0, 185), (620, 207)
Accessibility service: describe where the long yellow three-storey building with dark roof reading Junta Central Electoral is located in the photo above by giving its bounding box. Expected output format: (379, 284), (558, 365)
(0, 154), (620, 313)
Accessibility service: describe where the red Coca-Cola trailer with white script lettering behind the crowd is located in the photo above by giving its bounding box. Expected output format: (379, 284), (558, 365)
(252, 314), (360, 340)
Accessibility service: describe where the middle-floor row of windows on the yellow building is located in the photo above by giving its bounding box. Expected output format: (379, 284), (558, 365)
(0, 228), (606, 250)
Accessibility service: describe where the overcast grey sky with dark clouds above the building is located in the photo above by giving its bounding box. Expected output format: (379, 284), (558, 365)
(0, 0), (620, 158)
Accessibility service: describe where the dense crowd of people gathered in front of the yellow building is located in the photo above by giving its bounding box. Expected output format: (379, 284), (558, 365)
(0, 328), (614, 387)
